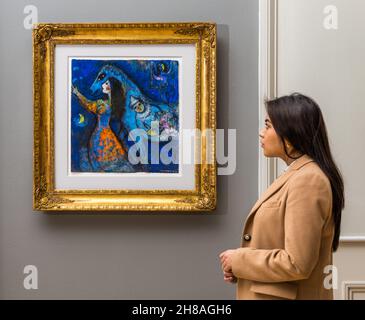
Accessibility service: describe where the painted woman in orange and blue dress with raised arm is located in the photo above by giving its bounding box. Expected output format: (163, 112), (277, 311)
(72, 80), (134, 172)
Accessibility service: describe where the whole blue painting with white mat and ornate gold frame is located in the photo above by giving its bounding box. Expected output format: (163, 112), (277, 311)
(33, 22), (216, 211)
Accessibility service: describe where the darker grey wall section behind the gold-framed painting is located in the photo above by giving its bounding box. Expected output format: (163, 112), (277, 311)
(0, 0), (258, 299)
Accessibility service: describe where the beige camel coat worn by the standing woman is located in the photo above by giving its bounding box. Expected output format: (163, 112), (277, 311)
(232, 155), (334, 299)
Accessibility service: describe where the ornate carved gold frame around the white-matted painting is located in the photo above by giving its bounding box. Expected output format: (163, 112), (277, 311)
(33, 23), (217, 211)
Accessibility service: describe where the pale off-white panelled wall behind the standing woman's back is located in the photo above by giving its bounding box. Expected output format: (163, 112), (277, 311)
(278, 0), (365, 299)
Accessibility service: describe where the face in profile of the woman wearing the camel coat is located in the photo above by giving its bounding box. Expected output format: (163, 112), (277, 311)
(259, 115), (284, 157)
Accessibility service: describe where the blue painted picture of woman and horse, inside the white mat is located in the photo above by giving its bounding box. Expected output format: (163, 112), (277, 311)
(70, 58), (179, 173)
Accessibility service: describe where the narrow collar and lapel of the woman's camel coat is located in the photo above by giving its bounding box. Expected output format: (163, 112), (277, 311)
(246, 154), (314, 221)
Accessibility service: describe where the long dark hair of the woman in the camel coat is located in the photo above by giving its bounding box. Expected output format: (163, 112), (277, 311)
(265, 93), (345, 251)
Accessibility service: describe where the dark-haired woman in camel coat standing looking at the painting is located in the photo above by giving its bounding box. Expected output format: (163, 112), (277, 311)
(219, 93), (344, 299)
